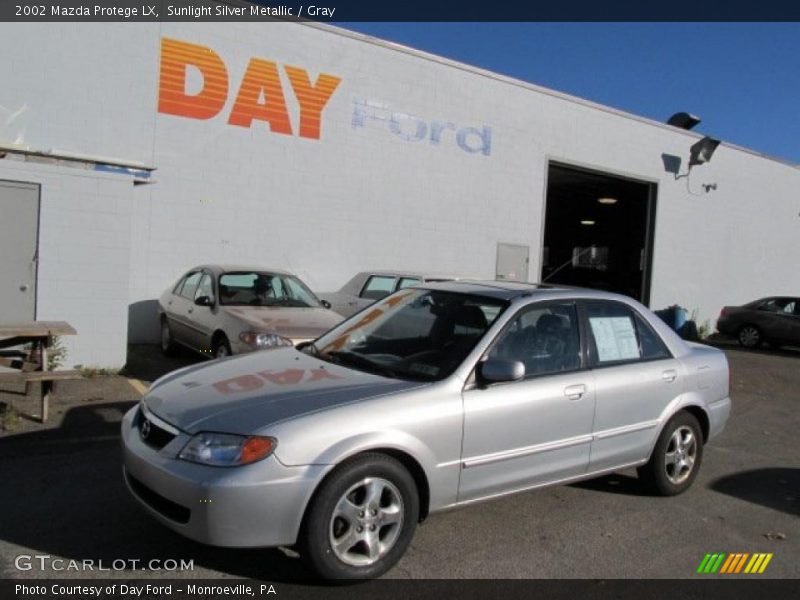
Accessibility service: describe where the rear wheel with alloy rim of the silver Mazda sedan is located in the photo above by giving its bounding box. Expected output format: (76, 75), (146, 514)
(638, 411), (703, 496)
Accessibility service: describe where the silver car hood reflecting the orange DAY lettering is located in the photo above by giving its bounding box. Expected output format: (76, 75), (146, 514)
(144, 348), (430, 435)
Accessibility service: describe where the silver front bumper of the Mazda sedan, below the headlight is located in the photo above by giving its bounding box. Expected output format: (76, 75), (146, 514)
(122, 406), (330, 548)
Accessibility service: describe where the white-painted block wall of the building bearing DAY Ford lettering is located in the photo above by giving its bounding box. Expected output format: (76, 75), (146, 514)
(0, 23), (800, 362)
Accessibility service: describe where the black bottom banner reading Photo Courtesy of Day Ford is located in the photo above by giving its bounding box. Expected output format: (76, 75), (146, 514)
(0, 576), (798, 600)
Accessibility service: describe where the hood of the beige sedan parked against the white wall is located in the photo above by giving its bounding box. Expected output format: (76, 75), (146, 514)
(220, 306), (344, 340)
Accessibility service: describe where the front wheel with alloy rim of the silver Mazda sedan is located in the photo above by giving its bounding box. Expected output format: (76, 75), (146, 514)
(299, 453), (419, 579)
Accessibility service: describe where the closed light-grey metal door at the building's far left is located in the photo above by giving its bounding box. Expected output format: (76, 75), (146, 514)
(0, 181), (39, 323)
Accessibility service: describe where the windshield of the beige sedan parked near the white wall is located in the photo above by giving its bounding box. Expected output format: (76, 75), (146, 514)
(219, 271), (320, 308)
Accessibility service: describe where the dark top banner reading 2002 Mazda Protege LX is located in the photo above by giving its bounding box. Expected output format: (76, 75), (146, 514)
(0, 0), (800, 23)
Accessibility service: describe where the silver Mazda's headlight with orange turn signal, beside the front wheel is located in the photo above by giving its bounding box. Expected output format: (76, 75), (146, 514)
(178, 432), (278, 467)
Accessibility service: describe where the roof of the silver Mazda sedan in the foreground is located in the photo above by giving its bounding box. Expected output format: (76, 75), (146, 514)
(416, 280), (631, 302)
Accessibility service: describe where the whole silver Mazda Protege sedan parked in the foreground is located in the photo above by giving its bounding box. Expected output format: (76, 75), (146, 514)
(122, 282), (731, 578)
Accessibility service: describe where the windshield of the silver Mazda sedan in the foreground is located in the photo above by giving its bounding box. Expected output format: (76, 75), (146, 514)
(305, 288), (507, 381)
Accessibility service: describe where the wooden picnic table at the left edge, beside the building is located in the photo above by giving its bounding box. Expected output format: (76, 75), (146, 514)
(0, 321), (80, 423)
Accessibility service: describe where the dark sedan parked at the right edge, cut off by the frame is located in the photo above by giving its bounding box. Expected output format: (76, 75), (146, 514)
(717, 296), (800, 348)
